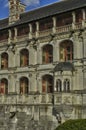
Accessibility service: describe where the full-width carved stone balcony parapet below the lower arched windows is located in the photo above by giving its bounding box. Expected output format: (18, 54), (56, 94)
(0, 93), (86, 105)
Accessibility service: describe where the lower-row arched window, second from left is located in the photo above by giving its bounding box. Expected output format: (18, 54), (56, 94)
(20, 77), (29, 94)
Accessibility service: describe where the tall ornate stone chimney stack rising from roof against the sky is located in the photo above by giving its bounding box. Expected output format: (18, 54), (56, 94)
(9, 0), (26, 24)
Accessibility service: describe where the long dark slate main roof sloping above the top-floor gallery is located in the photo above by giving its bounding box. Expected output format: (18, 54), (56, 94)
(0, 0), (86, 29)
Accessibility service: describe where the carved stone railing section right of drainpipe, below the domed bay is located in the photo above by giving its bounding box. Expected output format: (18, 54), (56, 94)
(54, 93), (86, 105)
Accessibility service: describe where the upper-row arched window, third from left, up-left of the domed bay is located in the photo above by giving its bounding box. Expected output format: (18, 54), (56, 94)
(42, 45), (53, 63)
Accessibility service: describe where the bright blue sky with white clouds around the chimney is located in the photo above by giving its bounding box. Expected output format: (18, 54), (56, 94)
(0, 0), (60, 19)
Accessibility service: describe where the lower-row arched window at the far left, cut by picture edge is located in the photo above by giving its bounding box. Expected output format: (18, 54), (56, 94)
(0, 78), (8, 94)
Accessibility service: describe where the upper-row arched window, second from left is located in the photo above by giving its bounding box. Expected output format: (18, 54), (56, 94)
(20, 49), (29, 67)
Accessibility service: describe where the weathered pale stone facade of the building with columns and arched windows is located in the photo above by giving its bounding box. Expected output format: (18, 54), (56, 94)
(0, 0), (86, 130)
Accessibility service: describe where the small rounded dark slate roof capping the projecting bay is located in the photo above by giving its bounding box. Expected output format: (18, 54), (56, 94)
(54, 62), (75, 72)
